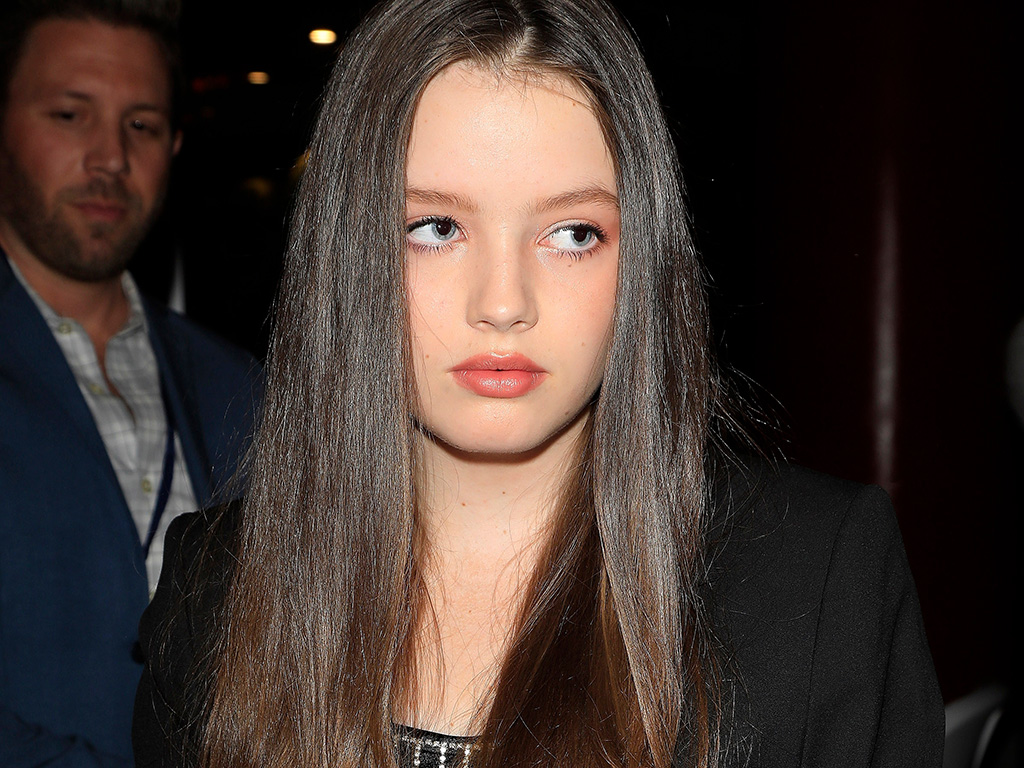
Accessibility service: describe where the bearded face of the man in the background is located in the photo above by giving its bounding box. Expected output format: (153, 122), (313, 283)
(0, 19), (180, 282)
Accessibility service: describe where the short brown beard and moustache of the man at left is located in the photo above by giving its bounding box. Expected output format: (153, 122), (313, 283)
(0, 146), (160, 283)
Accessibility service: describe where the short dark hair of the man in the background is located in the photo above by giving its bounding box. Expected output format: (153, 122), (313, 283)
(0, 0), (185, 126)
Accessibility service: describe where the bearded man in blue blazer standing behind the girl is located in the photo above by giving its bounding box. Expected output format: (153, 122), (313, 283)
(0, 0), (255, 768)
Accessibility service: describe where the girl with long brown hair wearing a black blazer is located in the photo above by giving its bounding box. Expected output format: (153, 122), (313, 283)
(134, 0), (942, 768)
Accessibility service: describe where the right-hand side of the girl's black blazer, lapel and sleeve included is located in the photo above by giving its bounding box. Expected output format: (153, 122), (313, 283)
(711, 467), (944, 768)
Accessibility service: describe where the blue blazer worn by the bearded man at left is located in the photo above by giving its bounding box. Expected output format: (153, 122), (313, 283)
(0, 252), (258, 768)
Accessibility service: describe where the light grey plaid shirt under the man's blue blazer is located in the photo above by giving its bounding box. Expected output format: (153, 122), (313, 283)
(10, 261), (197, 597)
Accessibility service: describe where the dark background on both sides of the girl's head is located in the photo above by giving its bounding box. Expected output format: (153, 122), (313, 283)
(135, 0), (1024, 700)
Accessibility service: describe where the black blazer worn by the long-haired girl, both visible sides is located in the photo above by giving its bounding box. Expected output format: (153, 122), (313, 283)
(133, 464), (943, 768)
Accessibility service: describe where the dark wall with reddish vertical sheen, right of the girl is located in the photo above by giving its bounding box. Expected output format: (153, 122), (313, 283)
(631, 0), (1024, 699)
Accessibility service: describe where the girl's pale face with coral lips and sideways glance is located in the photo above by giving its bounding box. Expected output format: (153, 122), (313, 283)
(406, 65), (620, 455)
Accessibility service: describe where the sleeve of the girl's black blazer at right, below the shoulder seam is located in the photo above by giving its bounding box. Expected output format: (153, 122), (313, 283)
(801, 487), (944, 768)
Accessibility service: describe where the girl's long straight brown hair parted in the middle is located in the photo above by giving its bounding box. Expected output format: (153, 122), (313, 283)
(201, 0), (717, 768)
